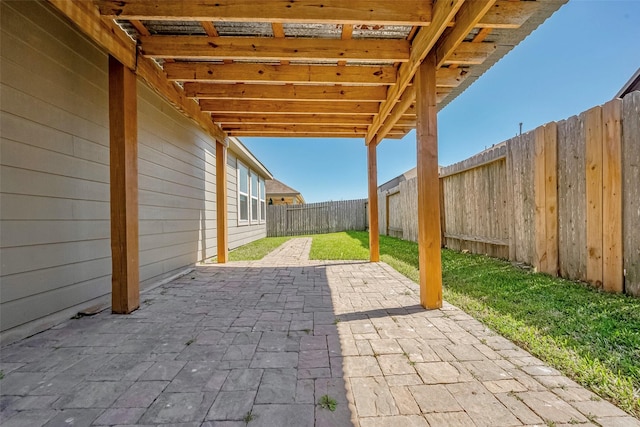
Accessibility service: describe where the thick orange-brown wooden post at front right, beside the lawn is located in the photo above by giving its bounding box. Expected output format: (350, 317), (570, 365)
(414, 50), (442, 309)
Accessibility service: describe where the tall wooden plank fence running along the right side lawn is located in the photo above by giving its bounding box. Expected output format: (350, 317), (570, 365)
(378, 92), (640, 296)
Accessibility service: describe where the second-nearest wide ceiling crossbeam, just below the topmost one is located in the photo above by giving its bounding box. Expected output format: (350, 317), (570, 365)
(139, 36), (410, 62)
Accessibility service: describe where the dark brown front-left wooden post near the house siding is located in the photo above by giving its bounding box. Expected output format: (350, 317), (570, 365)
(109, 56), (140, 314)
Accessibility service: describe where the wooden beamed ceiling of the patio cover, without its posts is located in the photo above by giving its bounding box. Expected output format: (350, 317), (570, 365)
(94, 0), (564, 143)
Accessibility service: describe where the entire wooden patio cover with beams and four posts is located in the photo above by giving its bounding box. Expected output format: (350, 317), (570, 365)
(48, 0), (566, 313)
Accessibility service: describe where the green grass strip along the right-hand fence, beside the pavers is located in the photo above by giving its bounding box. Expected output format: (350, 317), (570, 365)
(228, 232), (640, 416)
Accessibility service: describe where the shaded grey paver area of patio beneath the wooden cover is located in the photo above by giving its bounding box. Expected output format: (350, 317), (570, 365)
(0, 264), (351, 426)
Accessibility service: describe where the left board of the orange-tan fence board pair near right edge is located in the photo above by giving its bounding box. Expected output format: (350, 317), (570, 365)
(585, 107), (603, 287)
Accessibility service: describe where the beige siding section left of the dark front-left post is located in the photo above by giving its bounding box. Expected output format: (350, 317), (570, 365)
(0, 1), (111, 330)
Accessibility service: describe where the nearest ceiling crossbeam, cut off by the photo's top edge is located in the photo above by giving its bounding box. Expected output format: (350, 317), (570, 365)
(96, 0), (431, 25)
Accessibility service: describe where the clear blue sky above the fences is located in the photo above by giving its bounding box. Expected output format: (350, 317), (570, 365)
(242, 0), (640, 202)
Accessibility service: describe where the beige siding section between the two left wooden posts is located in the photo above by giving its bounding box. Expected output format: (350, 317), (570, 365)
(138, 83), (216, 282)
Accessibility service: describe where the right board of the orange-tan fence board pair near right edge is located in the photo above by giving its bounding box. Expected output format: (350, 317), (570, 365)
(602, 99), (624, 292)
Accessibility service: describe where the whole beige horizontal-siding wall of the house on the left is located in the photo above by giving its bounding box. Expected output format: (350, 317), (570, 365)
(0, 1), (266, 342)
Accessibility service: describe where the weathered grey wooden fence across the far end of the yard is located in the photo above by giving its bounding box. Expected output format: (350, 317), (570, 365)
(267, 199), (367, 237)
